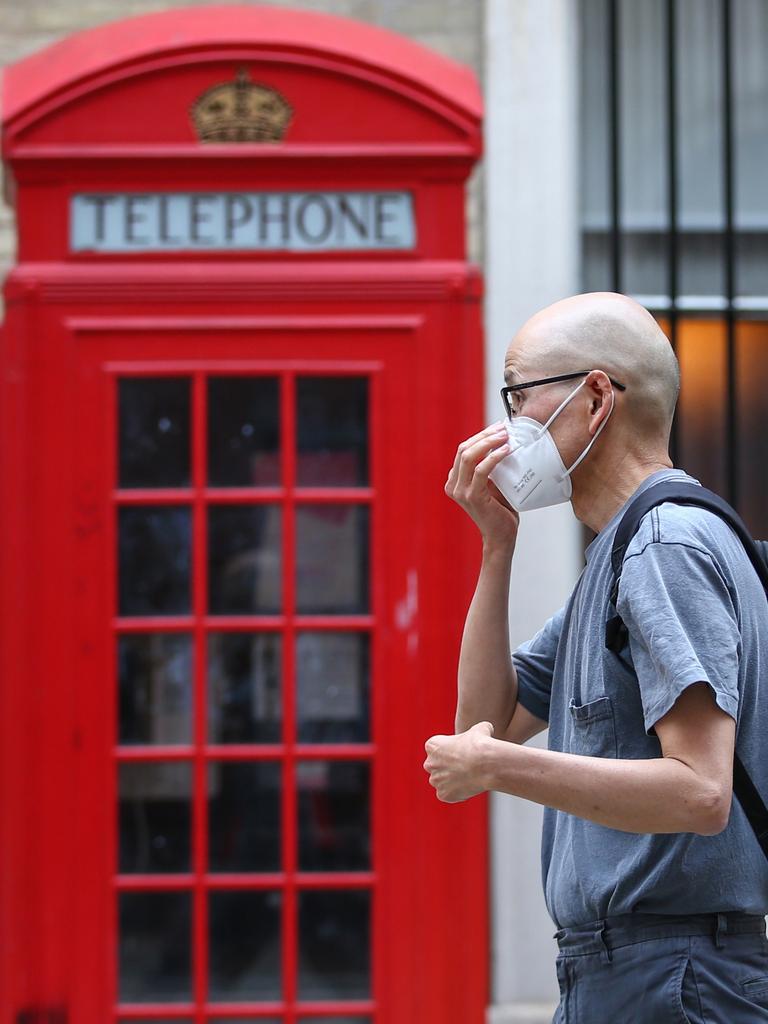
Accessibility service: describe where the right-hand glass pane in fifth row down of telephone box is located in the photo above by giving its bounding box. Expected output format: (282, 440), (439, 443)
(299, 890), (371, 999)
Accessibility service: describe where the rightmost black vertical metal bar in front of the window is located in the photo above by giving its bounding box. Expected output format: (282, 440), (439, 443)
(720, 0), (739, 508)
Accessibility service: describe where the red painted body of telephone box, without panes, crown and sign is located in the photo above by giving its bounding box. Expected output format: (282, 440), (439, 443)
(0, 6), (489, 1024)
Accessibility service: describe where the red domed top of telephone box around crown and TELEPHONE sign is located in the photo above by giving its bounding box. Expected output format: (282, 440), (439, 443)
(2, 6), (481, 263)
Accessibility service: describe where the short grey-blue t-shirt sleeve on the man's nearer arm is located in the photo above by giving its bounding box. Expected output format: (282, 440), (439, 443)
(616, 541), (741, 734)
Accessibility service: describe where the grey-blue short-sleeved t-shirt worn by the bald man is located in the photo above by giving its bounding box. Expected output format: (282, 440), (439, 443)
(512, 469), (768, 928)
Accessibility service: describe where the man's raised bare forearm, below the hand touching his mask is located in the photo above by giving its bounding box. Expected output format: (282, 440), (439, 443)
(455, 545), (517, 735)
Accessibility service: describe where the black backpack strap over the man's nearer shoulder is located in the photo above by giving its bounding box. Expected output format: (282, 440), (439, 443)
(605, 480), (768, 858)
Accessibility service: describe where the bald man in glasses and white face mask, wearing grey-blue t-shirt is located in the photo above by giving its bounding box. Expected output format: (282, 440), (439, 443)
(424, 293), (768, 1024)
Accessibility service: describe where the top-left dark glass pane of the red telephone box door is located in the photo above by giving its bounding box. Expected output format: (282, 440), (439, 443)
(118, 377), (189, 487)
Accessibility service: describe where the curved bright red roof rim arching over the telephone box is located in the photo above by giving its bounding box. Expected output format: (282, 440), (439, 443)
(3, 4), (482, 132)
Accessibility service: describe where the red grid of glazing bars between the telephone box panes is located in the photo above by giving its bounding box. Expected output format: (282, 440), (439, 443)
(107, 356), (385, 1024)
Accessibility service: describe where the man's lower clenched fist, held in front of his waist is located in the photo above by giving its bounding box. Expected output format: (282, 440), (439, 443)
(424, 722), (494, 804)
